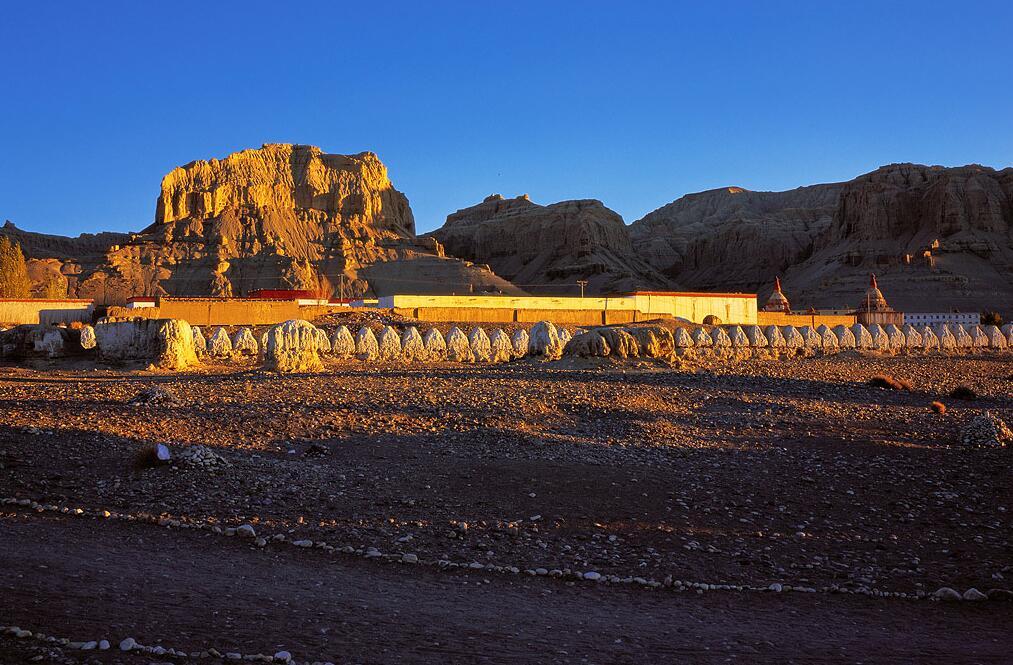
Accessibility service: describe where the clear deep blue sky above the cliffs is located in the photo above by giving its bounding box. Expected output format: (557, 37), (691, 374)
(0, 0), (1013, 234)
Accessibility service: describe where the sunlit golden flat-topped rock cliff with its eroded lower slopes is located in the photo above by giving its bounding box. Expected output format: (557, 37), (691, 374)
(0, 144), (517, 304)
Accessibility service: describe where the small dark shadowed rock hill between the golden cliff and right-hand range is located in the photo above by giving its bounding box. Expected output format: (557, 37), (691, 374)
(428, 195), (671, 294)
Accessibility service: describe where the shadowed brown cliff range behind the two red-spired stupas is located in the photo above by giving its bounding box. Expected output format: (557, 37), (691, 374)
(630, 164), (1013, 311)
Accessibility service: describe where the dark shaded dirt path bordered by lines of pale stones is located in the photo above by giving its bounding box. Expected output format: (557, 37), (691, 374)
(0, 513), (1013, 663)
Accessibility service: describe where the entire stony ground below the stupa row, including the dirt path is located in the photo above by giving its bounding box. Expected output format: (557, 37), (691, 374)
(0, 353), (1013, 663)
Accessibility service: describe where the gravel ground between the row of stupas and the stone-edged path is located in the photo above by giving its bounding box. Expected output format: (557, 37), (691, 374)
(0, 352), (1013, 662)
